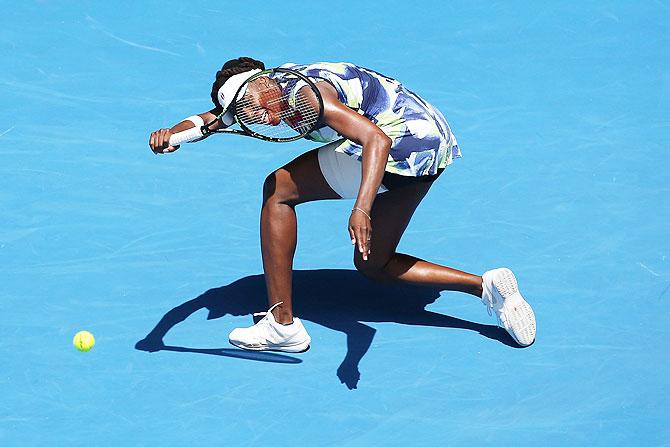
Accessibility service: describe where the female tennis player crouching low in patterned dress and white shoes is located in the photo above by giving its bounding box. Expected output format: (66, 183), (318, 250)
(149, 57), (536, 352)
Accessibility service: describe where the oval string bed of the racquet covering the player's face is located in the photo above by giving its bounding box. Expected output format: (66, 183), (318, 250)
(235, 73), (321, 139)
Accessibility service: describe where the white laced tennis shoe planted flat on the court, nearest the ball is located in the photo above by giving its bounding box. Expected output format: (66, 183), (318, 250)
(228, 302), (312, 352)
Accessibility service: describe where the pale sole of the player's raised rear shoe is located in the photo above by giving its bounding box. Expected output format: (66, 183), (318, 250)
(493, 269), (537, 347)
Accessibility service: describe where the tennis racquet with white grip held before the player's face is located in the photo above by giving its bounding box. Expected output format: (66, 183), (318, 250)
(170, 68), (323, 146)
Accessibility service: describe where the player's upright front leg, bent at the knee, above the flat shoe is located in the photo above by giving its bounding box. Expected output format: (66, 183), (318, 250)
(261, 149), (340, 323)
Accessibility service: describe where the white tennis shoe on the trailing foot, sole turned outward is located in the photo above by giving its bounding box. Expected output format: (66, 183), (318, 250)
(482, 268), (536, 346)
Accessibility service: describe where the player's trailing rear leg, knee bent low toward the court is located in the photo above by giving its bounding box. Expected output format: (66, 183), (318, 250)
(354, 183), (482, 297)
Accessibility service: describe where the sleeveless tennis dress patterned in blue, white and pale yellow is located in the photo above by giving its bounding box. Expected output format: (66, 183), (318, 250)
(282, 62), (461, 177)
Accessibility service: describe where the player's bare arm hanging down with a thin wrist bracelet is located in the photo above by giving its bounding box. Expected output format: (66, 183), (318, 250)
(317, 82), (392, 260)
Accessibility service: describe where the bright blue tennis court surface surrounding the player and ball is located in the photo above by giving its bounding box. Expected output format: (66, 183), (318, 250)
(0, 0), (670, 446)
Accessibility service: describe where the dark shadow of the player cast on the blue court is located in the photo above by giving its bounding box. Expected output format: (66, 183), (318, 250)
(135, 270), (518, 389)
